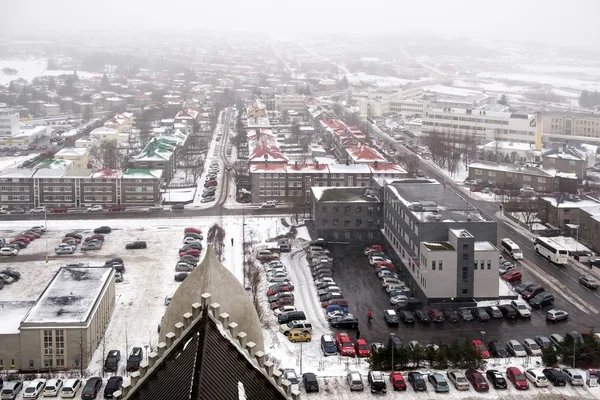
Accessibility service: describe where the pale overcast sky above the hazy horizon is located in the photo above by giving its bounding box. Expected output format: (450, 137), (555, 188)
(5, 0), (600, 47)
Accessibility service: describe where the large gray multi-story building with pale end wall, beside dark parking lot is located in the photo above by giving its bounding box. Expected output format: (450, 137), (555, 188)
(383, 179), (499, 302)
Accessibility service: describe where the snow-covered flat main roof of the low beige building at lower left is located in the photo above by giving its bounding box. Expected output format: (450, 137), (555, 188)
(23, 267), (113, 324)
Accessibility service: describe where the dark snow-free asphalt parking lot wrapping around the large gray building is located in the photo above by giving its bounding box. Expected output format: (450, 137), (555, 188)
(329, 245), (600, 344)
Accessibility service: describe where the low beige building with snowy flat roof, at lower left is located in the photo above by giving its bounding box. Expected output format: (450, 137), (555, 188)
(0, 267), (115, 371)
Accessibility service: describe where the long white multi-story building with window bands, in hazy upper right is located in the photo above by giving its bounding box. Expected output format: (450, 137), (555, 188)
(422, 108), (536, 143)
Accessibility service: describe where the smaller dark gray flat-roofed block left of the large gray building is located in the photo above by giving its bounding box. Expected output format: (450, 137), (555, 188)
(311, 187), (383, 242)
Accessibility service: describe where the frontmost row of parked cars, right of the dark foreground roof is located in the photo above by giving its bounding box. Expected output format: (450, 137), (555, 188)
(346, 367), (584, 393)
